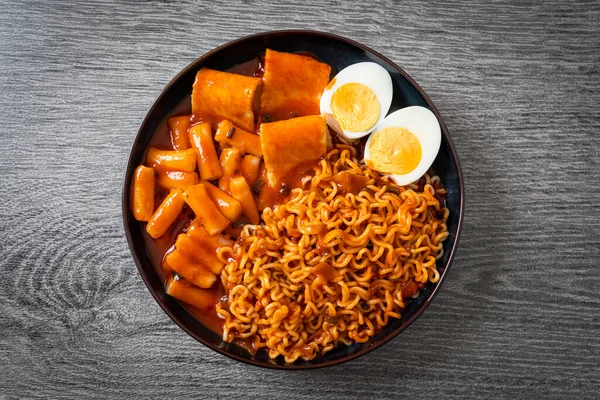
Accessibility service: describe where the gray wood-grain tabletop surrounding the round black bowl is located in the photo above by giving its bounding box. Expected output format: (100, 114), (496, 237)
(0, 0), (600, 399)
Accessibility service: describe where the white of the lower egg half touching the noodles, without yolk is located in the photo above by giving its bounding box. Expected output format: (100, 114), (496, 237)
(365, 106), (442, 186)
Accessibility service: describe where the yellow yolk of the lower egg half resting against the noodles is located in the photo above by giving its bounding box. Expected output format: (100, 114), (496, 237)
(367, 127), (422, 175)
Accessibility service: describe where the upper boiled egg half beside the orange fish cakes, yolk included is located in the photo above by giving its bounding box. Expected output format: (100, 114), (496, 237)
(321, 62), (393, 140)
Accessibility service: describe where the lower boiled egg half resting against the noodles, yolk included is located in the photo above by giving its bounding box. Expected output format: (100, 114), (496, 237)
(365, 106), (442, 186)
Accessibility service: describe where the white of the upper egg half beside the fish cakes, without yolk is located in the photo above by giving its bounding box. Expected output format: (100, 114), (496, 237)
(320, 62), (393, 140)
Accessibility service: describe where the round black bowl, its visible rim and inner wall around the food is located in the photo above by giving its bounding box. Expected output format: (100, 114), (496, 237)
(123, 30), (464, 369)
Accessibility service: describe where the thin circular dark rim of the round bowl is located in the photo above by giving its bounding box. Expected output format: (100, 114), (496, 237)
(122, 29), (465, 370)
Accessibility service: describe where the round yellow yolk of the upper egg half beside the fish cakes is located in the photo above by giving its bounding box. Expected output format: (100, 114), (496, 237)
(331, 83), (381, 132)
